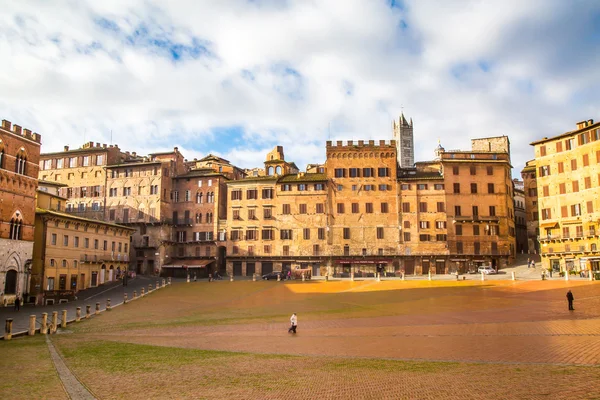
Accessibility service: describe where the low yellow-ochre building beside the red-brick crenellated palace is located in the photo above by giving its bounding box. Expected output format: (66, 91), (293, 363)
(30, 181), (135, 304)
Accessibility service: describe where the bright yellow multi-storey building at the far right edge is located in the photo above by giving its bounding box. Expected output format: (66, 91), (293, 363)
(531, 119), (600, 272)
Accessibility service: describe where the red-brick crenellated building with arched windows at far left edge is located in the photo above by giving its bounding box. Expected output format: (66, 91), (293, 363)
(0, 120), (41, 303)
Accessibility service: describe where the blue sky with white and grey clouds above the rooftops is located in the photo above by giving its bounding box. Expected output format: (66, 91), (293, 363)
(0, 0), (600, 176)
